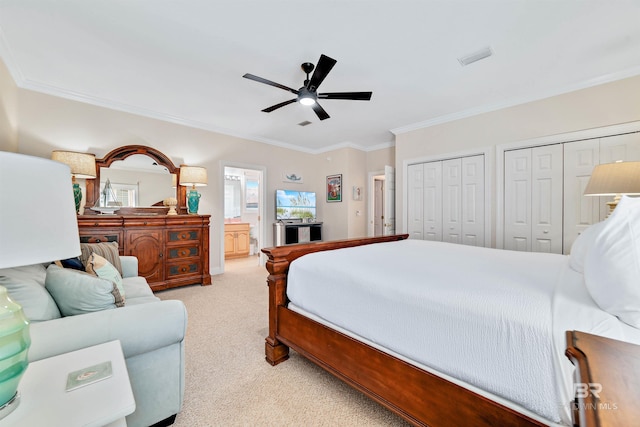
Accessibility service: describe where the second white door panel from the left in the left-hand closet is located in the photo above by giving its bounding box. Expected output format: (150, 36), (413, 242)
(423, 162), (442, 242)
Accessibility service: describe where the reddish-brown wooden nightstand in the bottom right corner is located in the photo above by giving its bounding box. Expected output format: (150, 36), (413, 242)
(565, 331), (640, 427)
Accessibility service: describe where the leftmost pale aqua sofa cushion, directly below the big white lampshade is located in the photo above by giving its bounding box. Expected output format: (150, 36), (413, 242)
(0, 264), (61, 322)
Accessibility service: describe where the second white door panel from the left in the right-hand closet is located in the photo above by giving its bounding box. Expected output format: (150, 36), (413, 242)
(531, 144), (563, 254)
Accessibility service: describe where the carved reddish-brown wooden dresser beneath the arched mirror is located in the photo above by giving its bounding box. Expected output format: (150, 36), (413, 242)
(78, 215), (211, 291)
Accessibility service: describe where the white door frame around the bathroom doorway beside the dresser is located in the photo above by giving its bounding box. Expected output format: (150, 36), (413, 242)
(221, 160), (267, 273)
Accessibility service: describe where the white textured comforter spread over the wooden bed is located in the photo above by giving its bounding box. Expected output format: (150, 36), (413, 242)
(287, 240), (640, 425)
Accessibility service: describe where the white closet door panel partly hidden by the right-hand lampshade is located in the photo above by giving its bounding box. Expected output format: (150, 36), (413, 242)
(563, 139), (600, 254)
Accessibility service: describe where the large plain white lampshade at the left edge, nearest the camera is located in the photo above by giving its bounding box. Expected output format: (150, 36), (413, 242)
(0, 151), (80, 268)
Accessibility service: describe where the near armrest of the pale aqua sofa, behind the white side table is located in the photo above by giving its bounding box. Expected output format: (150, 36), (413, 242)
(29, 300), (187, 362)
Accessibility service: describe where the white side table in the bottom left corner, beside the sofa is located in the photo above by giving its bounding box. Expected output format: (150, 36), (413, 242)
(0, 341), (136, 427)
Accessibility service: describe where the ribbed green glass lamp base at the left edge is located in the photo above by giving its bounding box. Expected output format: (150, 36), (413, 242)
(0, 286), (31, 419)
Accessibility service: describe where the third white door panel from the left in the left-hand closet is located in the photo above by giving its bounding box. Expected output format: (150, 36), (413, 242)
(442, 159), (462, 243)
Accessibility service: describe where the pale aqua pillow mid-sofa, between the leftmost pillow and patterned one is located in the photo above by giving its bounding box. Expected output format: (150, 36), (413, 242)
(45, 264), (123, 316)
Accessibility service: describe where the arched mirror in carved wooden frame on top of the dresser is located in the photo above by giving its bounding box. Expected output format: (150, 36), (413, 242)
(84, 145), (186, 215)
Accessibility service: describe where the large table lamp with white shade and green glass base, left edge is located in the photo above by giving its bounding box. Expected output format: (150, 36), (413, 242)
(0, 151), (80, 419)
